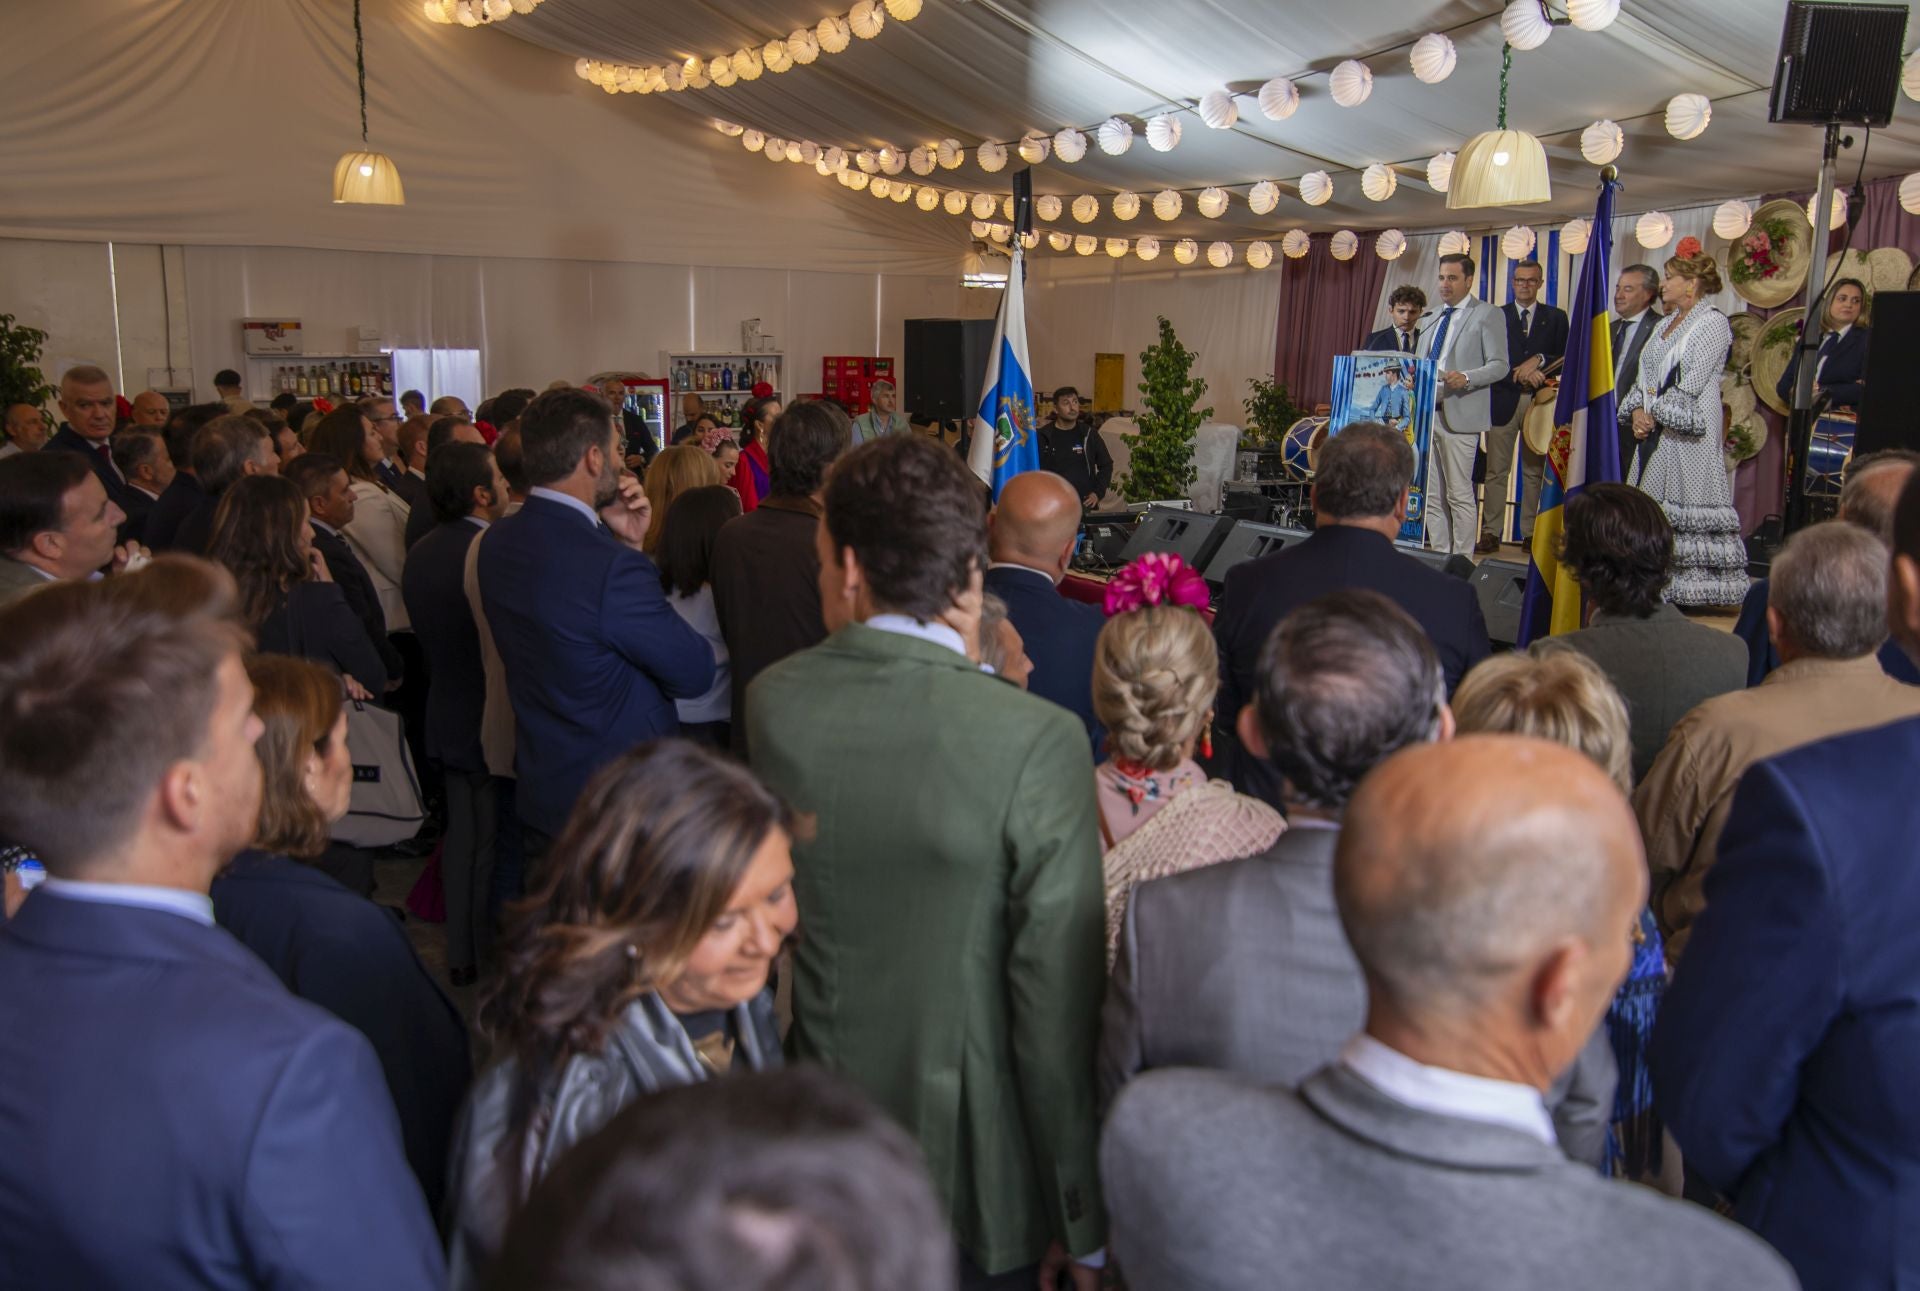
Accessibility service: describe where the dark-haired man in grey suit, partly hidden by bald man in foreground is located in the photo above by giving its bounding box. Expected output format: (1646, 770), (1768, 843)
(1100, 590), (1617, 1166)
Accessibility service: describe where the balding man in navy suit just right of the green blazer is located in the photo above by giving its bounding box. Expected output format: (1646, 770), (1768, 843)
(987, 471), (1106, 757)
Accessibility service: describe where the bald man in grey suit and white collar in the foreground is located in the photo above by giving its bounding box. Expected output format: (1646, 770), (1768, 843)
(1102, 736), (1797, 1291)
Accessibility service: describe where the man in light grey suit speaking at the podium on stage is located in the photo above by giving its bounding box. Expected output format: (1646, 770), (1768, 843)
(1419, 256), (1507, 555)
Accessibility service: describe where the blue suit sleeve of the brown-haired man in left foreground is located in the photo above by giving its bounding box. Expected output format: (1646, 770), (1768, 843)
(244, 1024), (447, 1291)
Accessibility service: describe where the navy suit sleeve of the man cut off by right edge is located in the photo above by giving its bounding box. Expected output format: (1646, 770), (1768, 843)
(1649, 763), (1843, 1195)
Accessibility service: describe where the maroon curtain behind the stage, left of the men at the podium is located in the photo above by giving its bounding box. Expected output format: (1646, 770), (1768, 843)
(1273, 232), (1386, 407)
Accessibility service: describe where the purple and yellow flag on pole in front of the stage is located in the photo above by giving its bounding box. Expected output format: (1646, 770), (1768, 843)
(1519, 181), (1620, 649)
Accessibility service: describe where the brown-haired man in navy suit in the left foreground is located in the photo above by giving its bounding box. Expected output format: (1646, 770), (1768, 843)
(0, 567), (445, 1291)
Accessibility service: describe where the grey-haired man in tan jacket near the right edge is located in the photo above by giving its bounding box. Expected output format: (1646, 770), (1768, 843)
(1634, 521), (1920, 962)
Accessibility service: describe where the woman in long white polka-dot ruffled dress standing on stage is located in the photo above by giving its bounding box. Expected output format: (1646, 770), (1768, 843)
(1620, 252), (1747, 609)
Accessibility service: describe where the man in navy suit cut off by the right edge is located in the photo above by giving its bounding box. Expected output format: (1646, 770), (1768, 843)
(1649, 464), (1920, 1287)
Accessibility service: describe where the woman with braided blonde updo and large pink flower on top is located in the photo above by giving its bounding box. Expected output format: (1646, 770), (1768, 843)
(1092, 553), (1286, 968)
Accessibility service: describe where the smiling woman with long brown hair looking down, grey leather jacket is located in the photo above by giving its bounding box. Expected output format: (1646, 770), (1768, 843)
(447, 737), (797, 1291)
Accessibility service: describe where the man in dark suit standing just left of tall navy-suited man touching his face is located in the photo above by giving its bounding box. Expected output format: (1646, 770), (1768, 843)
(399, 444), (507, 986)
